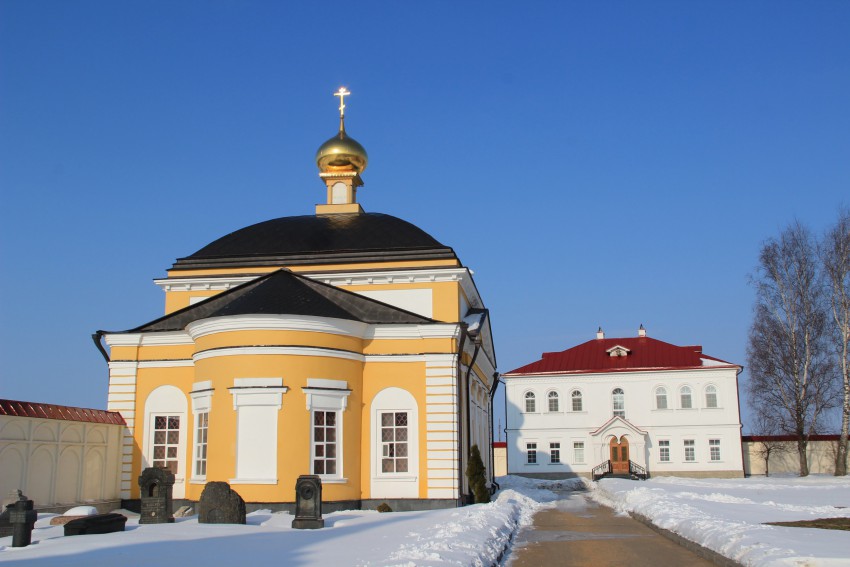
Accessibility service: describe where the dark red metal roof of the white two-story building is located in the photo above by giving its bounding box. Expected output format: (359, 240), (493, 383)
(505, 337), (737, 375)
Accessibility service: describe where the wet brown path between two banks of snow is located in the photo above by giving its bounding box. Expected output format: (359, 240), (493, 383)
(506, 492), (714, 567)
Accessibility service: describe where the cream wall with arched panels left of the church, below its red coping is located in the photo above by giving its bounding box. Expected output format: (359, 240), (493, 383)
(0, 415), (124, 508)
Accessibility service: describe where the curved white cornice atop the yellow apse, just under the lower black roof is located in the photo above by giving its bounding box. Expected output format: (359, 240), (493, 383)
(186, 315), (369, 340)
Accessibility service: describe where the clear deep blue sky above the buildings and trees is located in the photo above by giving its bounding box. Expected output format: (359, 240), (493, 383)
(0, 0), (850, 434)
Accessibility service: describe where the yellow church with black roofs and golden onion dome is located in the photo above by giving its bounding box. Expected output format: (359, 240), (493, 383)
(95, 89), (497, 510)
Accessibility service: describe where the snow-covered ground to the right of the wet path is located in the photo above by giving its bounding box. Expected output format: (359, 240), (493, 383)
(591, 476), (850, 566)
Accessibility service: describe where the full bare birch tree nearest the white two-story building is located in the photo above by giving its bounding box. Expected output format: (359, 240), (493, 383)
(747, 223), (836, 476)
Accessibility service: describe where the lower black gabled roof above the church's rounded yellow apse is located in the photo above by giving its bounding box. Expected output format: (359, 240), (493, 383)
(104, 270), (437, 334)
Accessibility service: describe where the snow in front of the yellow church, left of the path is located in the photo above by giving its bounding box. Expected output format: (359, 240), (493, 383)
(0, 477), (581, 567)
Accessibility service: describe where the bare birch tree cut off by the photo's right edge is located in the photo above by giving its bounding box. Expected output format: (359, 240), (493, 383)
(820, 208), (850, 476)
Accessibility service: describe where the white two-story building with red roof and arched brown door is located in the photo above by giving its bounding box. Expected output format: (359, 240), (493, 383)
(502, 326), (743, 478)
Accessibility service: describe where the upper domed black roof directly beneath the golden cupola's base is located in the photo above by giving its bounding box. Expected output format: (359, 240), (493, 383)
(167, 213), (457, 270)
